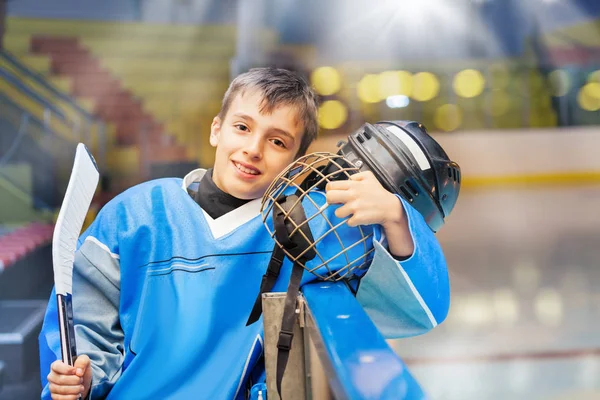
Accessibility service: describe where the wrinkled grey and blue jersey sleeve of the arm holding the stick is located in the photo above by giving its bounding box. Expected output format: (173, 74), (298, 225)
(39, 205), (124, 399)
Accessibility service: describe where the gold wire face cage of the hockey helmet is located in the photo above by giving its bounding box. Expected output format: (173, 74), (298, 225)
(261, 152), (374, 281)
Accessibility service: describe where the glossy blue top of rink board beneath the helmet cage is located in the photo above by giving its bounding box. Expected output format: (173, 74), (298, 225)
(303, 282), (427, 400)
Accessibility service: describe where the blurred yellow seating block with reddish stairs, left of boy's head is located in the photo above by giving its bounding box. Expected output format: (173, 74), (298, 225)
(1, 17), (286, 170)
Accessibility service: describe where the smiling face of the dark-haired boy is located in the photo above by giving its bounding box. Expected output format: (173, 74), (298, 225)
(210, 90), (304, 200)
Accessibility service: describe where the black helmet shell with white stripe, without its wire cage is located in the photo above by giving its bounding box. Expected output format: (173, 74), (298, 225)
(330, 121), (461, 232)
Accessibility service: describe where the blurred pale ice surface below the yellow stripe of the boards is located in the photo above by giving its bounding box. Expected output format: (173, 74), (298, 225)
(392, 185), (600, 400)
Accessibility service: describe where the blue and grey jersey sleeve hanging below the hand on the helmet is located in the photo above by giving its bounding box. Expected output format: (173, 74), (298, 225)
(356, 197), (450, 338)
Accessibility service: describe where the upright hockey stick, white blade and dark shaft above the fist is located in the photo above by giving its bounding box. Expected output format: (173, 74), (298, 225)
(52, 143), (100, 372)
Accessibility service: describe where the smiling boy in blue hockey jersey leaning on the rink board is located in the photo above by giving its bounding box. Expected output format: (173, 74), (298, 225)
(40, 68), (449, 399)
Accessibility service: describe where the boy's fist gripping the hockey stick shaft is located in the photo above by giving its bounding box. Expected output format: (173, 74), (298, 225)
(48, 354), (92, 400)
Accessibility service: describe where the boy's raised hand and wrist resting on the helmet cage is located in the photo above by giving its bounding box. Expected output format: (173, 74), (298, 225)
(325, 171), (414, 257)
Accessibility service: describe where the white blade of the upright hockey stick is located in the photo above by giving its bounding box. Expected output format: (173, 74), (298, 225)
(52, 143), (100, 295)
